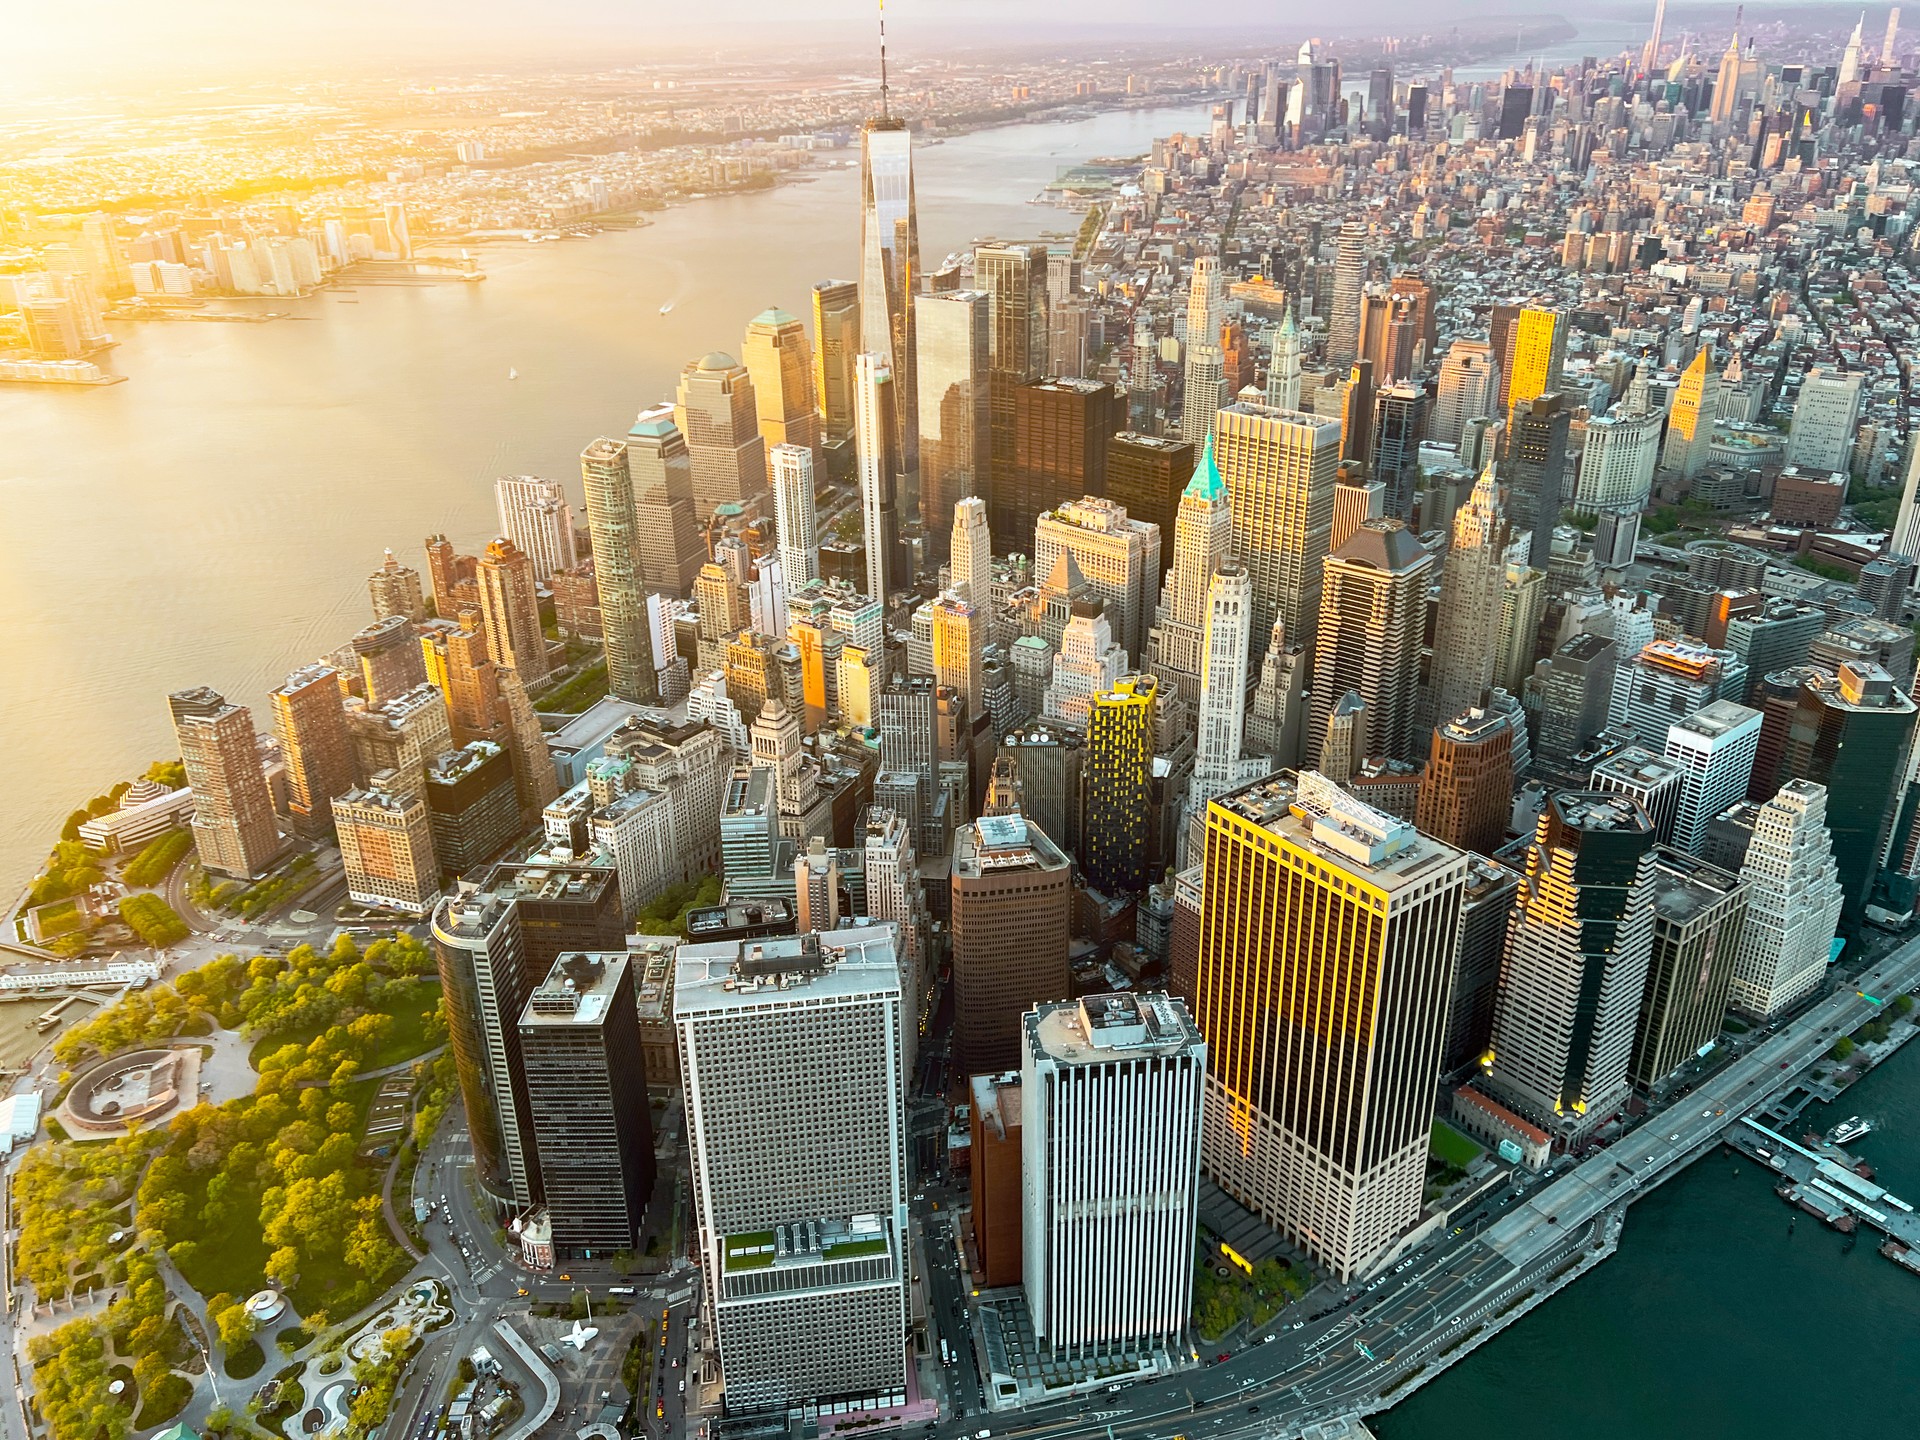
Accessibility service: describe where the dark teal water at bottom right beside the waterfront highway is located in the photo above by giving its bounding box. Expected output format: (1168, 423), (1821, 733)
(1369, 990), (1920, 1440)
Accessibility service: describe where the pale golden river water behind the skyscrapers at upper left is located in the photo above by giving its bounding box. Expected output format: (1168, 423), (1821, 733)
(0, 106), (1208, 893)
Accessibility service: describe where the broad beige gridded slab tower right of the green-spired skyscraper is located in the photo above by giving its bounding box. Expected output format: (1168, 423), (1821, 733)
(1213, 401), (1340, 653)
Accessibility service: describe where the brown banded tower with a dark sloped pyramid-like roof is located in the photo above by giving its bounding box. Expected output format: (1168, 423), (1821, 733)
(1308, 520), (1434, 760)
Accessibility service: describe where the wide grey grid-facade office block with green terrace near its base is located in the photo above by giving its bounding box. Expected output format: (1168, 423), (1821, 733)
(674, 925), (908, 1413)
